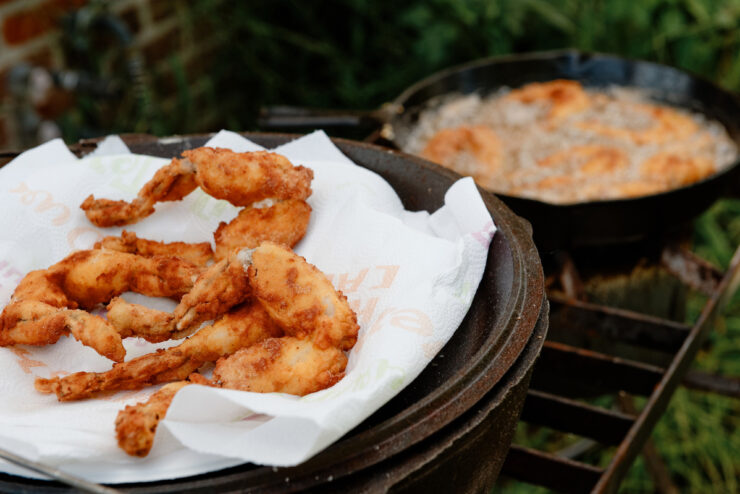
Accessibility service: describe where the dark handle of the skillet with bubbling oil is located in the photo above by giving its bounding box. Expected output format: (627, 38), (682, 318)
(257, 106), (387, 129)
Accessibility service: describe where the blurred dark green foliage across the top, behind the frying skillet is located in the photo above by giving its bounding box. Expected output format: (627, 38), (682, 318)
(55, 0), (740, 140)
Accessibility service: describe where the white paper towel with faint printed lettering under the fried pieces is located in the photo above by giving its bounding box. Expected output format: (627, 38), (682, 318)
(0, 131), (495, 483)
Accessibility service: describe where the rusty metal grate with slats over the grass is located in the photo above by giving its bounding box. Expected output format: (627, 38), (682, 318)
(502, 246), (740, 493)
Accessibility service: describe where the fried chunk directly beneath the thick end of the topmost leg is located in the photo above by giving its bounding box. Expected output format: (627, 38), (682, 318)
(213, 199), (311, 261)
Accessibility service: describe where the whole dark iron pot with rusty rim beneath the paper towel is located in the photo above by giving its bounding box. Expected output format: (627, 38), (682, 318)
(0, 134), (547, 493)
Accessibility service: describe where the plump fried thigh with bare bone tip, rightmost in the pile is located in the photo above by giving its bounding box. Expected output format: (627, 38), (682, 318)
(248, 242), (359, 350)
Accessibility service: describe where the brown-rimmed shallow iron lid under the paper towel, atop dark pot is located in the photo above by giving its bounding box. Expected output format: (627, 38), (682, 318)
(0, 134), (547, 493)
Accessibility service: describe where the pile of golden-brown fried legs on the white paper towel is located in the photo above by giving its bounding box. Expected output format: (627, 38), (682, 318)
(0, 148), (359, 456)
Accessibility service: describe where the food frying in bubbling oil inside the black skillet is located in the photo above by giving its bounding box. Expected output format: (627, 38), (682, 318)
(404, 80), (738, 204)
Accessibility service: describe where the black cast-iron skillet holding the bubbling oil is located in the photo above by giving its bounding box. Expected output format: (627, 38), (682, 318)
(262, 50), (740, 251)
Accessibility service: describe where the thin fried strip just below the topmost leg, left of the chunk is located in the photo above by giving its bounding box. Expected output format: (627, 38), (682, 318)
(94, 230), (213, 266)
